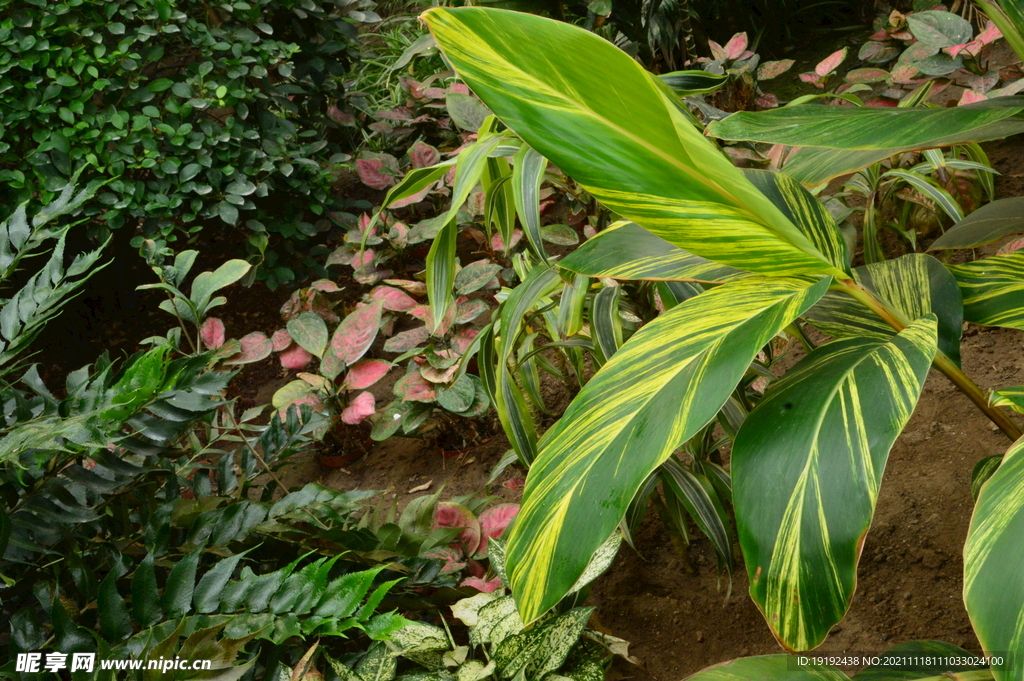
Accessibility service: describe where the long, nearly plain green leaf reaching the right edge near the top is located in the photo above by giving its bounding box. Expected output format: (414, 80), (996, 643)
(708, 97), (1024, 187)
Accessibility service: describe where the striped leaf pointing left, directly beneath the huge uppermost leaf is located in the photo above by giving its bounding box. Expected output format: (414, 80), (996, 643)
(558, 220), (750, 284)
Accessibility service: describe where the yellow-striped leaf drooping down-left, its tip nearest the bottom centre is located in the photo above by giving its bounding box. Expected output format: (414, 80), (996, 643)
(506, 278), (830, 622)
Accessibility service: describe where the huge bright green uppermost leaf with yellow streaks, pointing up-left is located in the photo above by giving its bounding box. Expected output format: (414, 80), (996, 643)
(423, 7), (841, 274)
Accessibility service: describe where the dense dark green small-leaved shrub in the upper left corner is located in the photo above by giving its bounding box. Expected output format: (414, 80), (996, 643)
(0, 0), (379, 258)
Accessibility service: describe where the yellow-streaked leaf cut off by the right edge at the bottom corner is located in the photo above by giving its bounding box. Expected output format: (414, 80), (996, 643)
(964, 438), (1024, 681)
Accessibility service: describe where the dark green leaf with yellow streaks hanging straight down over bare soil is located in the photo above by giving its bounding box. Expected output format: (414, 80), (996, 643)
(732, 315), (936, 650)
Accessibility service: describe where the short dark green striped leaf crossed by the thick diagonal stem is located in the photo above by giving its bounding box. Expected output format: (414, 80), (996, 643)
(804, 253), (964, 365)
